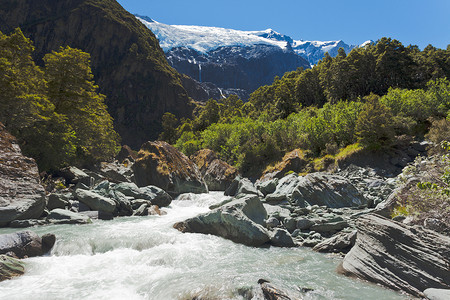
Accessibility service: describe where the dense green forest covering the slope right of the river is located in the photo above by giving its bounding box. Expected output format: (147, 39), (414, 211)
(165, 38), (450, 175)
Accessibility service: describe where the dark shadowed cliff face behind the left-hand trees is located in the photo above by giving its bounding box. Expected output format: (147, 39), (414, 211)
(0, 0), (193, 148)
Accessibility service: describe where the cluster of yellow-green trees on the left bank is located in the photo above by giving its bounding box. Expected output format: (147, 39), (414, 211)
(0, 29), (119, 171)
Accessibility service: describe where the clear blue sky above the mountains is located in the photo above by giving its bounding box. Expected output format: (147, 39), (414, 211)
(118, 0), (450, 49)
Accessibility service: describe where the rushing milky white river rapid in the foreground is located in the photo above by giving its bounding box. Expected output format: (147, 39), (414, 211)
(0, 192), (407, 300)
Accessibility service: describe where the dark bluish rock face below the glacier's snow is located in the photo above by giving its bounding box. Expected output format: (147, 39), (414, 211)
(166, 45), (310, 100)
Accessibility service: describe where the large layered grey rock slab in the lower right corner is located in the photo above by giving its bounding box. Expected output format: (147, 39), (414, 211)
(338, 214), (450, 297)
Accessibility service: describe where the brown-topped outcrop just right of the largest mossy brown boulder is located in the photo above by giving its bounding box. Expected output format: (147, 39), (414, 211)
(191, 149), (238, 191)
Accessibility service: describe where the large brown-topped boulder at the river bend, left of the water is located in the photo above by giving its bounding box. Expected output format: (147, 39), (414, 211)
(133, 141), (208, 196)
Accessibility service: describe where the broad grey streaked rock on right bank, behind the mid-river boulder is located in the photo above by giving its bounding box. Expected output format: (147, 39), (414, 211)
(291, 173), (367, 208)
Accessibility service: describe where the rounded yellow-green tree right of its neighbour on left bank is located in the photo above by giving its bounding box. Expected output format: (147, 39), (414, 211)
(44, 46), (119, 164)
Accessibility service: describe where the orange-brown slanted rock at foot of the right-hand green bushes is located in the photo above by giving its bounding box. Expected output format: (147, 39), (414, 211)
(261, 149), (308, 181)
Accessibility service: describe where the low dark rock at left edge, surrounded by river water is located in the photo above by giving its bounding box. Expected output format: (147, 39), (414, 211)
(0, 231), (53, 258)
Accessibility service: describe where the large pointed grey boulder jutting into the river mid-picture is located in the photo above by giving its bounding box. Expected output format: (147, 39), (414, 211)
(174, 195), (270, 247)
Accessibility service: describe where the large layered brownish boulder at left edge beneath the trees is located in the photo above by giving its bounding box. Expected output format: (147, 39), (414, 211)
(0, 123), (45, 226)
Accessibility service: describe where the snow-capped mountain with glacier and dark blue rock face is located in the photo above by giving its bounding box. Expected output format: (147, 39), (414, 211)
(136, 15), (370, 100)
